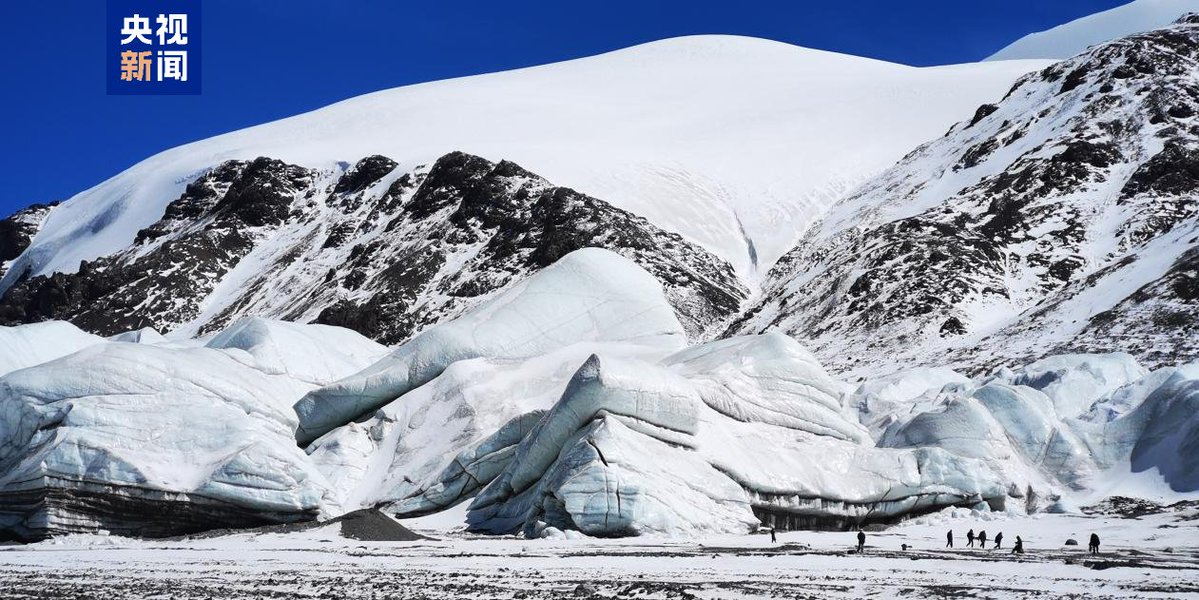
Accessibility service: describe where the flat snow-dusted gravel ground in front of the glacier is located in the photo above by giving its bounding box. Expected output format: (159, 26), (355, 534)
(0, 511), (1199, 600)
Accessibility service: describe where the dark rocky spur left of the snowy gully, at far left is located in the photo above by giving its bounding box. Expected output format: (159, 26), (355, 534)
(0, 158), (313, 335)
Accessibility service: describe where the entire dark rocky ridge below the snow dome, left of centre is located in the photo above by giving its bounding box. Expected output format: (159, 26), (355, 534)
(0, 152), (747, 343)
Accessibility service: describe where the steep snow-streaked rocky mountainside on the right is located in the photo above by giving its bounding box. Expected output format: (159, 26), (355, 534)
(729, 23), (1199, 372)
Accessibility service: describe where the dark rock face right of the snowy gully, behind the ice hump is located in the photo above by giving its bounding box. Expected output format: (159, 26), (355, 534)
(317, 152), (745, 343)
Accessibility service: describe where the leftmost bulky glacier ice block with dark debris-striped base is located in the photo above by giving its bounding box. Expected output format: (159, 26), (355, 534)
(0, 342), (327, 539)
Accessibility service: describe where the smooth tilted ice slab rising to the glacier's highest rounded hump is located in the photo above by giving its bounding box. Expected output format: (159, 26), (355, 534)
(296, 248), (686, 443)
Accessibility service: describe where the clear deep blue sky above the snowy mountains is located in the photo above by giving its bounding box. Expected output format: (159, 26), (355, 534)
(0, 0), (1123, 216)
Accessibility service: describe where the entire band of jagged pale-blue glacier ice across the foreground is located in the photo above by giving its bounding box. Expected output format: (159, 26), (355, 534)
(0, 248), (1199, 540)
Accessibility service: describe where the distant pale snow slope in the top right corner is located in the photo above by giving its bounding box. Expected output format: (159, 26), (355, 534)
(987, 0), (1199, 60)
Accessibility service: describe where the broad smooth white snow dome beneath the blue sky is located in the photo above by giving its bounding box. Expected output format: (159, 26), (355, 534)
(0, 36), (1044, 290)
